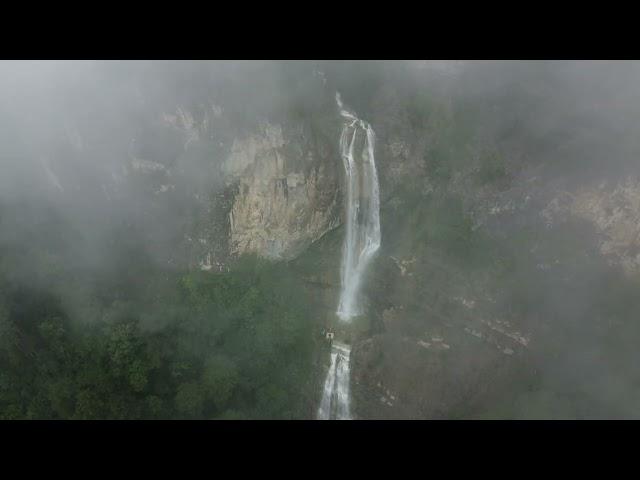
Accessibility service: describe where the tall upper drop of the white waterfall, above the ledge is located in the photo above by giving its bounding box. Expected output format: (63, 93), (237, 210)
(336, 93), (380, 321)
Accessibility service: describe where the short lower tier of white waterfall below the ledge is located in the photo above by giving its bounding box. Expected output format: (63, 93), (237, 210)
(318, 342), (351, 420)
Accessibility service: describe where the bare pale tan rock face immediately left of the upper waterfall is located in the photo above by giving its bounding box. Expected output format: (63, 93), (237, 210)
(223, 123), (341, 260)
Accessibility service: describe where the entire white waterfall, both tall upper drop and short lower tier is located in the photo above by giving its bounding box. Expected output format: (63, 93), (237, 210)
(318, 93), (380, 420)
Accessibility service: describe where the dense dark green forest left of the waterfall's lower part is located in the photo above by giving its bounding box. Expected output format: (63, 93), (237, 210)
(0, 236), (315, 419)
